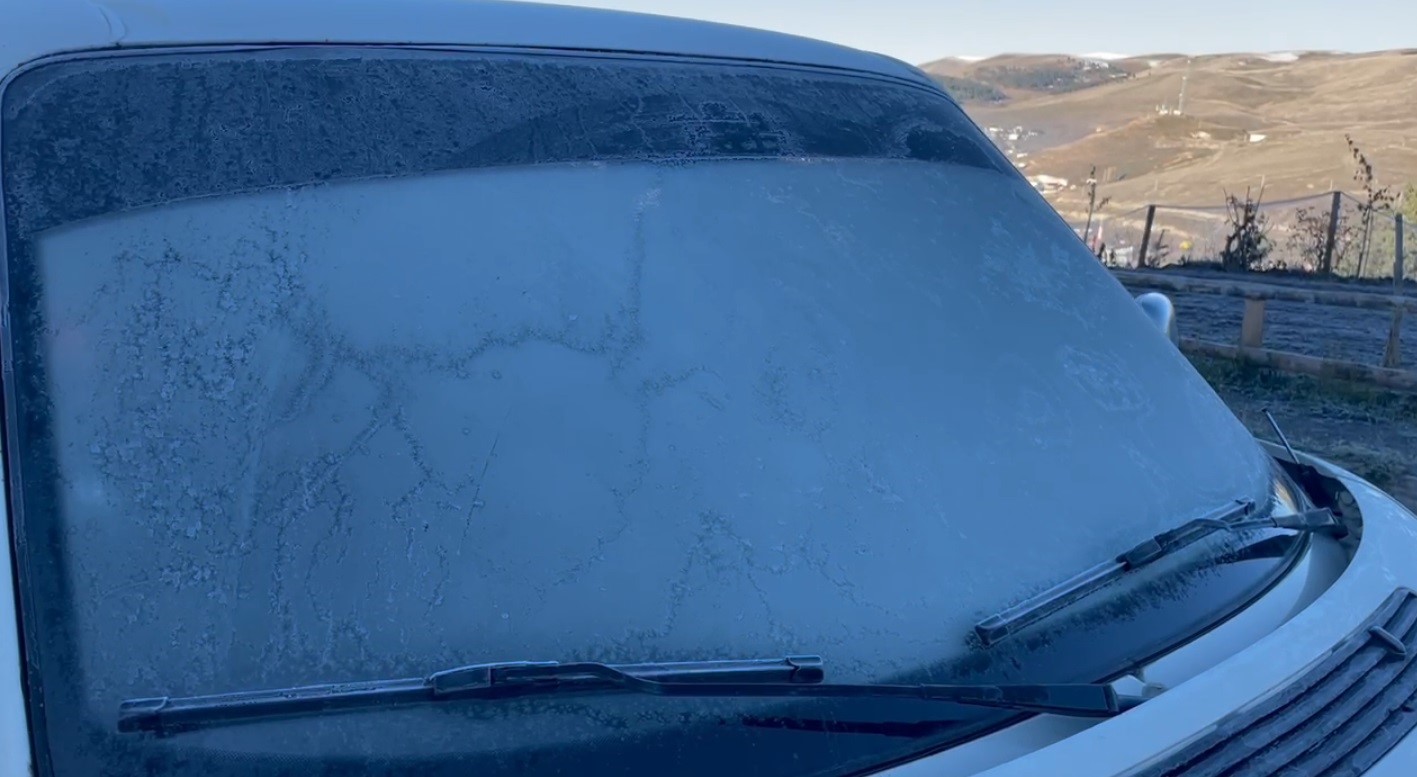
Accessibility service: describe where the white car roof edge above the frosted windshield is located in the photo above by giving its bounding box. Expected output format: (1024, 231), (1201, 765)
(0, 0), (930, 84)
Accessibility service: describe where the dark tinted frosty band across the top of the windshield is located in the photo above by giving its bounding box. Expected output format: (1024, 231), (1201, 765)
(3, 48), (1013, 235)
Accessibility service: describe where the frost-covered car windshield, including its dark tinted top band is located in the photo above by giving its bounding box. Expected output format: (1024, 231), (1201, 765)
(3, 50), (1274, 776)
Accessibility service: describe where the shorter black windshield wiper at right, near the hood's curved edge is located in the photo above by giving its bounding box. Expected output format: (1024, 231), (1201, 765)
(975, 501), (1346, 647)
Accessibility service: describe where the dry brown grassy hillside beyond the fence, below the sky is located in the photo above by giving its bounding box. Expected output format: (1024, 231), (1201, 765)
(922, 50), (1417, 219)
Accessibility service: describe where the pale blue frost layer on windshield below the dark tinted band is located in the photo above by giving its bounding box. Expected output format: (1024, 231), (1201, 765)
(37, 162), (1253, 723)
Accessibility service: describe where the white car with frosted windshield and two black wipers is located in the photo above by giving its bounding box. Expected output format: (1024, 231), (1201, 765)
(0, 0), (1417, 777)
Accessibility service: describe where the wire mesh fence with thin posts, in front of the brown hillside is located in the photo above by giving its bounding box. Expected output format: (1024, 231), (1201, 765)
(1074, 191), (1417, 279)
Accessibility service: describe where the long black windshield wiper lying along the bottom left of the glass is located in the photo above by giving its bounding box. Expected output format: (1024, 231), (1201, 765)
(118, 656), (1138, 734)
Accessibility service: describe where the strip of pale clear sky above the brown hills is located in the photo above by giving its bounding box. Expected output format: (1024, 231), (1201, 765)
(550, 0), (1417, 64)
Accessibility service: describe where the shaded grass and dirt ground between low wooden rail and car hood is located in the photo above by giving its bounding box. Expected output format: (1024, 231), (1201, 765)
(1192, 357), (1417, 510)
